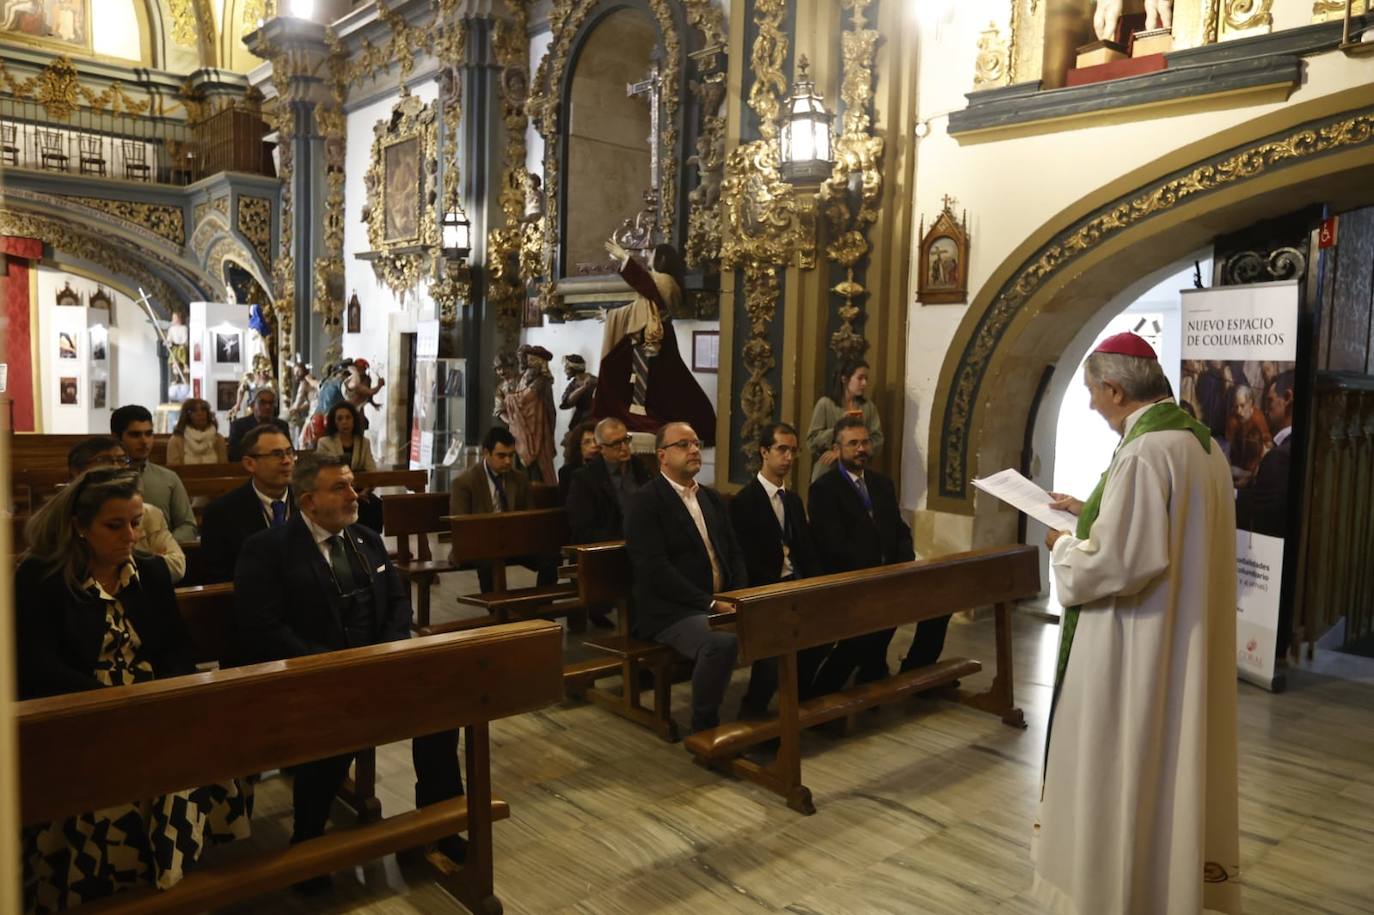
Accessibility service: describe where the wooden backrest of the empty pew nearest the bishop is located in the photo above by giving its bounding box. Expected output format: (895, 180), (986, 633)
(716, 544), (1040, 664)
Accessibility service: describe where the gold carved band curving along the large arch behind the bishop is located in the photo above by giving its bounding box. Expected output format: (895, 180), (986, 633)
(940, 111), (1374, 499)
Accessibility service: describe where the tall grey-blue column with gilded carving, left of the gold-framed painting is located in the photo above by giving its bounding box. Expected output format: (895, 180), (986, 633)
(245, 16), (333, 378)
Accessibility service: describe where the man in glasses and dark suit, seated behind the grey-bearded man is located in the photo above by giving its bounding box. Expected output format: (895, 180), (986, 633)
(201, 426), (295, 581)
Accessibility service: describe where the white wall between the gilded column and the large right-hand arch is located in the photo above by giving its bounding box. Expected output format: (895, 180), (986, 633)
(894, 33), (1370, 508)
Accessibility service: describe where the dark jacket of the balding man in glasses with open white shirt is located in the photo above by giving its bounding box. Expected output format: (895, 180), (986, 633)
(625, 474), (749, 639)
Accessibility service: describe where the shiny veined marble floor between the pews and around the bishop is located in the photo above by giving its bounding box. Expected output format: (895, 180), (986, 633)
(217, 563), (1374, 915)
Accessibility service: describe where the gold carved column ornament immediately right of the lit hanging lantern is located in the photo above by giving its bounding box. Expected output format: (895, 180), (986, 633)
(822, 0), (883, 360)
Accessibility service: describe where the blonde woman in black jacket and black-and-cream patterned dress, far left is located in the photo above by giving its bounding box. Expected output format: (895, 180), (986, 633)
(15, 467), (249, 912)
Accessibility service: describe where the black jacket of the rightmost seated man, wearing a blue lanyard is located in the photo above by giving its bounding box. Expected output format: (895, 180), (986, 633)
(808, 462), (916, 573)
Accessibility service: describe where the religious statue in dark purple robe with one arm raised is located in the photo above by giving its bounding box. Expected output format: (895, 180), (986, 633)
(592, 242), (716, 445)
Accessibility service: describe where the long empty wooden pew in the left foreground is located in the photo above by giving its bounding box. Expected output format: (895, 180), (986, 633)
(15, 621), (562, 915)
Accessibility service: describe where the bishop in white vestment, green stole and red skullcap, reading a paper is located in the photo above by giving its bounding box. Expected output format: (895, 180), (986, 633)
(1032, 334), (1241, 915)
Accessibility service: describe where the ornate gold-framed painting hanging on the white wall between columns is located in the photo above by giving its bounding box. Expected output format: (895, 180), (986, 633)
(361, 88), (440, 294)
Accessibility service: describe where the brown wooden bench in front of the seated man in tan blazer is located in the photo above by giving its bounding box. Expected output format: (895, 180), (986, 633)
(422, 508), (585, 632)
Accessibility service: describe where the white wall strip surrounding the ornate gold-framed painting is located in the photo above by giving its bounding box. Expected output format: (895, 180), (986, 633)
(342, 80), (439, 455)
